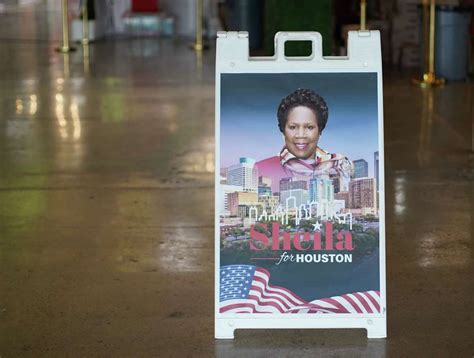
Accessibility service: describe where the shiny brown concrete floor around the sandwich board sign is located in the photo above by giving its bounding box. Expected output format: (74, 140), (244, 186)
(0, 1), (474, 357)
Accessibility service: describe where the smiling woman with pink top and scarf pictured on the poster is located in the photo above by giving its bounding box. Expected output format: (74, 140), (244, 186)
(256, 89), (353, 192)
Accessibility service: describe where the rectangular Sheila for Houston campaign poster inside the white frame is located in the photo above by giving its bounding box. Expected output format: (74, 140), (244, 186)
(217, 73), (381, 315)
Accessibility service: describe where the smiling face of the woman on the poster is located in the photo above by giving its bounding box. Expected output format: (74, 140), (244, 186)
(284, 106), (319, 159)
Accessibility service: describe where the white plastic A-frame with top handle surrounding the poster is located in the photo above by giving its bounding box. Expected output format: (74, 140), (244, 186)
(214, 31), (387, 339)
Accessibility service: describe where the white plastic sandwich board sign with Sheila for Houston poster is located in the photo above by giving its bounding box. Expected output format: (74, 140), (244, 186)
(215, 31), (386, 339)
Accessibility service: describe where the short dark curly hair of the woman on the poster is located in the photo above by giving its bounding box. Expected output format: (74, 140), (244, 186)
(277, 88), (329, 133)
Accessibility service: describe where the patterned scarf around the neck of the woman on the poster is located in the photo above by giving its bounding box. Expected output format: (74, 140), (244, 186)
(280, 147), (354, 178)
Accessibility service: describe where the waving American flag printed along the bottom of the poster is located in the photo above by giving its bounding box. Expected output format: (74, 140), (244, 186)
(219, 265), (380, 314)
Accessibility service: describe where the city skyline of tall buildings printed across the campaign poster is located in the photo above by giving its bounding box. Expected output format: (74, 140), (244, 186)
(221, 157), (378, 218)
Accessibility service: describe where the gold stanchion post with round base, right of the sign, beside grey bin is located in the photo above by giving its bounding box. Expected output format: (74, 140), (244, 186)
(412, 0), (445, 87)
